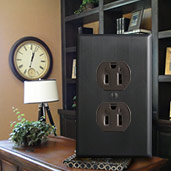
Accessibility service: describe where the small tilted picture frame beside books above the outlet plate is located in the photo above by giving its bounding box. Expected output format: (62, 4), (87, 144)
(128, 10), (143, 31)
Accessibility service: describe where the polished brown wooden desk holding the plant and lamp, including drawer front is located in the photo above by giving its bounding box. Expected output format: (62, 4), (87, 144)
(0, 137), (168, 171)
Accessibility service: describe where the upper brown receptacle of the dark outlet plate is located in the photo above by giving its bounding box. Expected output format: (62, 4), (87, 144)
(97, 61), (131, 90)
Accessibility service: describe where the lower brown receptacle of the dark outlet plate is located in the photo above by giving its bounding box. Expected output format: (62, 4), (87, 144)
(96, 102), (131, 131)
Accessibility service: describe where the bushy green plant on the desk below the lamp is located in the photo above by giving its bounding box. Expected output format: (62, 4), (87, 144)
(9, 107), (56, 146)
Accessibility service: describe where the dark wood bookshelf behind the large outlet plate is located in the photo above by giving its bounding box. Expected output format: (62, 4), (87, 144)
(59, 0), (171, 158)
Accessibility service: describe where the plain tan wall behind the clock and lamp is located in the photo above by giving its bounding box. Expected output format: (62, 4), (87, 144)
(0, 0), (62, 139)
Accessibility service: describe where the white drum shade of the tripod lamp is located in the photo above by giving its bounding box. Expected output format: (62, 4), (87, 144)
(24, 79), (59, 104)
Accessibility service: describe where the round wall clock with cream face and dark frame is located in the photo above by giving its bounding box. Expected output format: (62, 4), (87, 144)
(9, 37), (52, 81)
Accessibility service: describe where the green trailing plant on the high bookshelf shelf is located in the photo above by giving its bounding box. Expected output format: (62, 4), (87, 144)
(74, 0), (99, 14)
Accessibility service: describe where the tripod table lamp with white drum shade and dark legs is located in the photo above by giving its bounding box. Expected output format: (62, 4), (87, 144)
(24, 79), (59, 134)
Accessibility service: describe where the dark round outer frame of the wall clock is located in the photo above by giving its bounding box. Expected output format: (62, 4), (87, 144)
(9, 36), (53, 82)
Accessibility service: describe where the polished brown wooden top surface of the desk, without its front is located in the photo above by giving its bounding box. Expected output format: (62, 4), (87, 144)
(0, 136), (168, 171)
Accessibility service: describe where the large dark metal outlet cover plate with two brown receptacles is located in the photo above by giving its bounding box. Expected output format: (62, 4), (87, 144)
(76, 35), (152, 157)
